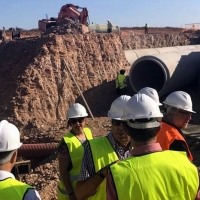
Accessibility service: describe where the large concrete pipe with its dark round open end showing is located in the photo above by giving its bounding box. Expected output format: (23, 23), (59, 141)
(129, 49), (200, 96)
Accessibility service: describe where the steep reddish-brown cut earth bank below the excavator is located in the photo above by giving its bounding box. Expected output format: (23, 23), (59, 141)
(0, 30), (129, 138)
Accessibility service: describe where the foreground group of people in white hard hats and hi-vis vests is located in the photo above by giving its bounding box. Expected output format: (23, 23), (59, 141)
(0, 83), (200, 200)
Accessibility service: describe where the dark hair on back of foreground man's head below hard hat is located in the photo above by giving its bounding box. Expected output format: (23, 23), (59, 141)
(125, 119), (161, 142)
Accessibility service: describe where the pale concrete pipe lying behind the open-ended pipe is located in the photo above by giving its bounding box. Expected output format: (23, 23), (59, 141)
(124, 45), (200, 66)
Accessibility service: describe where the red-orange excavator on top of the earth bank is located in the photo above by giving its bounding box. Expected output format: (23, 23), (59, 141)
(38, 4), (89, 32)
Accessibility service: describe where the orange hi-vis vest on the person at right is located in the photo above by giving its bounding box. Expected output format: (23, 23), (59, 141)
(157, 122), (193, 161)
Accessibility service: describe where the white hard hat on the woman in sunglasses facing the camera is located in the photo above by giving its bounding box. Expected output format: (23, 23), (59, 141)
(67, 103), (88, 118)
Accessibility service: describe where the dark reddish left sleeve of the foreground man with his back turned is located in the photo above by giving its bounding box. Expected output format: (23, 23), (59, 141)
(106, 170), (118, 200)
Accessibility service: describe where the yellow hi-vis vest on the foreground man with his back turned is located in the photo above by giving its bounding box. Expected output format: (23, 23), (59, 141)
(110, 150), (199, 200)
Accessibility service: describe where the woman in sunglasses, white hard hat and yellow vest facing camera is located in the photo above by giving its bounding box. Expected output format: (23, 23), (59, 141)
(58, 103), (92, 200)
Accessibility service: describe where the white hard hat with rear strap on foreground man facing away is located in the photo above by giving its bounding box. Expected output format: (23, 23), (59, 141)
(123, 93), (163, 128)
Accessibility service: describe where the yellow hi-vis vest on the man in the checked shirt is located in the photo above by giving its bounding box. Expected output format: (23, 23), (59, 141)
(88, 137), (119, 200)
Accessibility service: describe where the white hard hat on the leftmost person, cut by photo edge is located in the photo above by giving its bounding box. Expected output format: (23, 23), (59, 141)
(0, 120), (22, 152)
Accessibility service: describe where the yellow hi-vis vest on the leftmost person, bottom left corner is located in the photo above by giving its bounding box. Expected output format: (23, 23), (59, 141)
(0, 178), (33, 200)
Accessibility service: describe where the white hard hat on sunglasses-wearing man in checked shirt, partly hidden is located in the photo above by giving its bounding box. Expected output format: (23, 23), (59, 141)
(108, 95), (131, 120)
